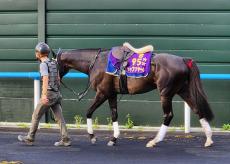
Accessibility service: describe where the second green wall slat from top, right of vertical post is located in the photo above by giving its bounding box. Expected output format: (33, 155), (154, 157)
(47, 11), (230, 25)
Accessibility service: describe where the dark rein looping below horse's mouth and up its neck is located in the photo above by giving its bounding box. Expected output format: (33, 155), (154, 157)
(52, 48), (101, 101)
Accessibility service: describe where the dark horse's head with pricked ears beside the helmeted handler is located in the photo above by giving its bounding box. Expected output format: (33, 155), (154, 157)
(52, 48), (70, 79)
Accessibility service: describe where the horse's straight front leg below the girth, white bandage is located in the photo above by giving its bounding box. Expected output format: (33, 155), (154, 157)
(107, 94), (120, 146)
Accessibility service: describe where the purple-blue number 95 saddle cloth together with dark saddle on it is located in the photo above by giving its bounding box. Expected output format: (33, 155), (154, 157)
(106, 47), (152, 78)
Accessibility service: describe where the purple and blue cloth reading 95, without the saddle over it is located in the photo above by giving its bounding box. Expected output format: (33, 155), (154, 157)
(106, 51), (152, 78)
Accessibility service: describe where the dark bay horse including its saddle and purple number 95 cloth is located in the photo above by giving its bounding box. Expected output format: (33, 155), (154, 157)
(54, 43), (213, 147)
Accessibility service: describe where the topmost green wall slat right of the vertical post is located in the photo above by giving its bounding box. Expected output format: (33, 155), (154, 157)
(47, 0), (230, 11)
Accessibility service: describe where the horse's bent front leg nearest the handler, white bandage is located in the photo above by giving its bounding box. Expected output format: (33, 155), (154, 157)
(86, 92), (107, 144)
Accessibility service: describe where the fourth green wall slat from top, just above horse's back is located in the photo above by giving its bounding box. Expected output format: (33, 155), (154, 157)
(47, 36), (230, 50)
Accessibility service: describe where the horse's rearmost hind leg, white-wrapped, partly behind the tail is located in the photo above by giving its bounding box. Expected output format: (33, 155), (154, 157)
(179, 87), (214, 147)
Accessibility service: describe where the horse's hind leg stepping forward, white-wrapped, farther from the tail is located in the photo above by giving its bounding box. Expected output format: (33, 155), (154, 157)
(146, 96), (173, 147)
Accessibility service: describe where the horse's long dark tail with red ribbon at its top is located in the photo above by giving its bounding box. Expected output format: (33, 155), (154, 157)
(184, 58), (214, 121)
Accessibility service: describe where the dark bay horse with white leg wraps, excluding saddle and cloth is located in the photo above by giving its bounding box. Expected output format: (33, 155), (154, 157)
(56, 49), (213, 147)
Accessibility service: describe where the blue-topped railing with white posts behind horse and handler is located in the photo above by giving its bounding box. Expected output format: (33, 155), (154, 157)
(0, 72), (230, 133)
